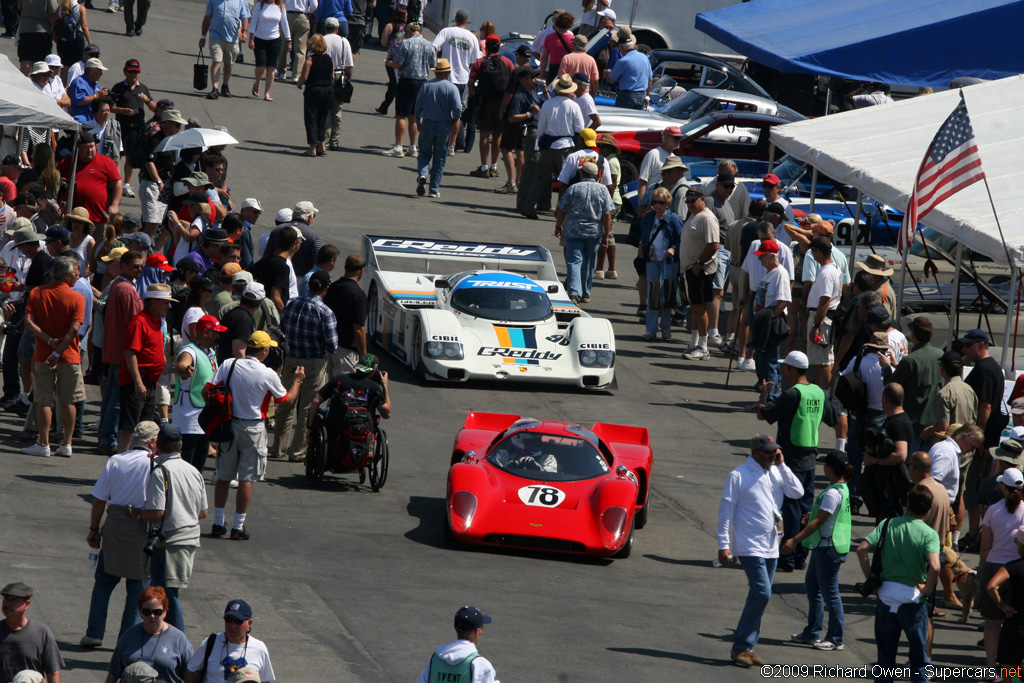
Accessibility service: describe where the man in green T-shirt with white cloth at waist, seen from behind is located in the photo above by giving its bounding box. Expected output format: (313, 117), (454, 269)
(857, 484), (939, 683)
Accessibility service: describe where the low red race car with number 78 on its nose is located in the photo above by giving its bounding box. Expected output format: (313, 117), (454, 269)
(445, 413), (653, 557)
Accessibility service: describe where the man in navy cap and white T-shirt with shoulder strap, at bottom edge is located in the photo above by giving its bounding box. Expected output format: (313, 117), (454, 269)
(184, 599), (274, 683)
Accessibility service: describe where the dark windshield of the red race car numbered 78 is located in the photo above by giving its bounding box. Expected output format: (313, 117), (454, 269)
(487, 431), (610, 481)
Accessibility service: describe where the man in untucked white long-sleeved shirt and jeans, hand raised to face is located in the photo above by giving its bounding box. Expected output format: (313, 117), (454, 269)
(718, 434), (804, 669)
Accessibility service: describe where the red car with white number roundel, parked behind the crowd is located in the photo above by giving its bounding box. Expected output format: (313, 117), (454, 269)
(598, 112), (792, 185)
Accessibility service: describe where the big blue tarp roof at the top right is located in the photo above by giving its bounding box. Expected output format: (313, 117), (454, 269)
(696, 0), (1024, 87)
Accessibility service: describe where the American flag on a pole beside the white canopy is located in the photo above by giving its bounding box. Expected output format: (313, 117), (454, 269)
(897, 96), (985, 253)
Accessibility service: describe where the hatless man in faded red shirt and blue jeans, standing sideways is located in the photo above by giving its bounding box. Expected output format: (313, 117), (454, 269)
(96, 251), (146, 456)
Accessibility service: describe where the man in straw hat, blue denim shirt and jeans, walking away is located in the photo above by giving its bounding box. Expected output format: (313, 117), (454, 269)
(415, 57), (462, 198)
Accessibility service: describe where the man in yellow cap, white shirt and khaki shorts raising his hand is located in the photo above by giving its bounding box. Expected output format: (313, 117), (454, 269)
(211, 330), (306, 541)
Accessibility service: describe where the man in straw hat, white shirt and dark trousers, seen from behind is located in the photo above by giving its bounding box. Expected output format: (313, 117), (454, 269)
(519, 74), (587, 220)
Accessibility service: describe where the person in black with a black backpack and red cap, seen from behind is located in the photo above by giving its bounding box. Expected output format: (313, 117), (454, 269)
(469, 35), (515, 178)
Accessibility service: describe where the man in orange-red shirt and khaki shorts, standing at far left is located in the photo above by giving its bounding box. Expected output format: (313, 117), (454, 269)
(22, 257), (85, 458)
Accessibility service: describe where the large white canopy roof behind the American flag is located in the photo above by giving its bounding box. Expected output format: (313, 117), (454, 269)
(771, 76), (1024, 268)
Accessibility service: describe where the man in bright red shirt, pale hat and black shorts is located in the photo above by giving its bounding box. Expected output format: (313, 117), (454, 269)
(117, 283), (173, 453)
